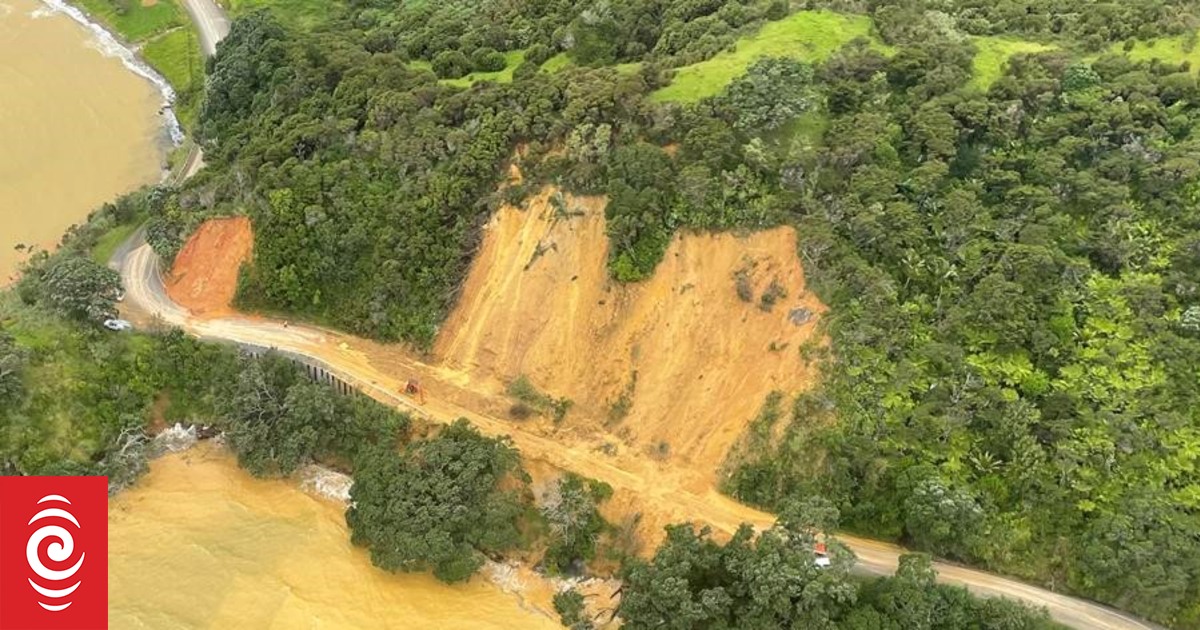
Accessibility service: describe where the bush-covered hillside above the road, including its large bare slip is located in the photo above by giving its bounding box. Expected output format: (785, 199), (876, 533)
(124, 0), (1200, 628)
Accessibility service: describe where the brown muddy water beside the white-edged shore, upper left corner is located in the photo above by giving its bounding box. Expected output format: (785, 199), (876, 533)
(0, 0), (166, 280)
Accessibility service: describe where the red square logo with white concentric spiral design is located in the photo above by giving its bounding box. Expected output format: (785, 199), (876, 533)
(0, 476), (108, 630)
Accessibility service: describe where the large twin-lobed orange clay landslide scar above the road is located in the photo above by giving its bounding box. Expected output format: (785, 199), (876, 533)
(434, 188), (824, 473)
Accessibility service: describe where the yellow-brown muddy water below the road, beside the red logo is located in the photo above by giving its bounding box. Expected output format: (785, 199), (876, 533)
(109, 444), (560, 630)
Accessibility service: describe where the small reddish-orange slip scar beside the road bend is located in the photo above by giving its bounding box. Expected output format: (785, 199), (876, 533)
(166, 216), (254, 316)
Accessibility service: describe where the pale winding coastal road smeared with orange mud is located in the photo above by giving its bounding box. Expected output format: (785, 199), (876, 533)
(112, 0), (1160, 630)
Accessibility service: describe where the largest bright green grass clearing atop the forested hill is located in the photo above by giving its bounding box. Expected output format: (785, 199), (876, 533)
(650, 11), (890, 103)
